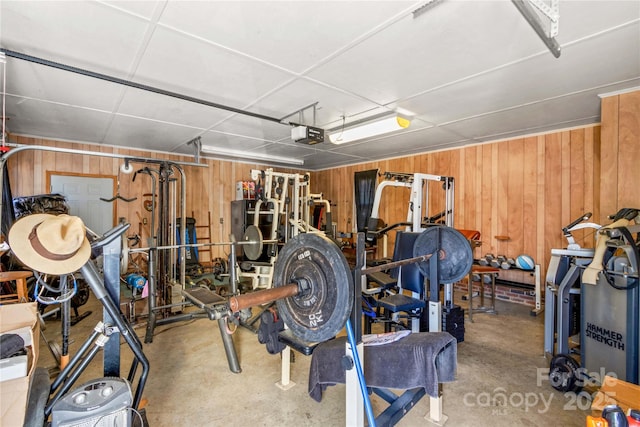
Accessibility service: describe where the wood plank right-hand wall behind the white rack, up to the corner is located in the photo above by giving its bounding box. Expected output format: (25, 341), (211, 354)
(311, 126), (604, 282)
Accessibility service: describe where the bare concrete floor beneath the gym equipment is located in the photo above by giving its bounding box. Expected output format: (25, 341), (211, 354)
(39, 290), (590, 427)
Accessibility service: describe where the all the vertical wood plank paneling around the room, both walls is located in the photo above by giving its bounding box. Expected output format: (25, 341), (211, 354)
(8, 91), (640, 281)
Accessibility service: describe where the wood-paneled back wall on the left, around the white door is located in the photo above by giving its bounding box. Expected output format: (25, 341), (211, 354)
(7, 136), (295, 262)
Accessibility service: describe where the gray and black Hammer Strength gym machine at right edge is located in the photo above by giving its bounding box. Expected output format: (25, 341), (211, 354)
(545, 208), (640, 392)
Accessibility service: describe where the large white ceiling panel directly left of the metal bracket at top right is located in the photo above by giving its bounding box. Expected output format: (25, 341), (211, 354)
(309, 1), (546, 104)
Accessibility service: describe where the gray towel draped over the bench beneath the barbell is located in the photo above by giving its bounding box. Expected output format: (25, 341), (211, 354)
(309, 332), (458, 402)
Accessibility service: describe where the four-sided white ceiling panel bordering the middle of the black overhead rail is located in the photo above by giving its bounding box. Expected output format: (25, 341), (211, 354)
(135, 27), (291, 108)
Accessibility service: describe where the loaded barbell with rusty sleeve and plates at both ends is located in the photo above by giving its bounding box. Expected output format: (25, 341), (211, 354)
(222, 226), (473, 342)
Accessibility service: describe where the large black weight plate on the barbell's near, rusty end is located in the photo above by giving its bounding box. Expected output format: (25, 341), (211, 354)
(273, 233), (354, 342)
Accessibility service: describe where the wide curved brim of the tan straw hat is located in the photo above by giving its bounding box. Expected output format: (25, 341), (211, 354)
(7, 214), (91, 276)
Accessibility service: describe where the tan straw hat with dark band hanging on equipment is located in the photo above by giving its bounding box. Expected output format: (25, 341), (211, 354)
(8, 214), (91, 275)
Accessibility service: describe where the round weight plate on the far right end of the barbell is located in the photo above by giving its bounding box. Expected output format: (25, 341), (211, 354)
(413, 225), (473, 283)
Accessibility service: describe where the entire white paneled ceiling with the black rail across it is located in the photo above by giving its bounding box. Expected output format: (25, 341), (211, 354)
(0, 0), (640, 170)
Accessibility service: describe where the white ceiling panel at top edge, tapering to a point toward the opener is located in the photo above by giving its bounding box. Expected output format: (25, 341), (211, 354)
(160, 1), (418, 73)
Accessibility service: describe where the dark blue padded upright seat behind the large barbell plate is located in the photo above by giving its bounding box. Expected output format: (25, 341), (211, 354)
(365, 231), (426, 333)
